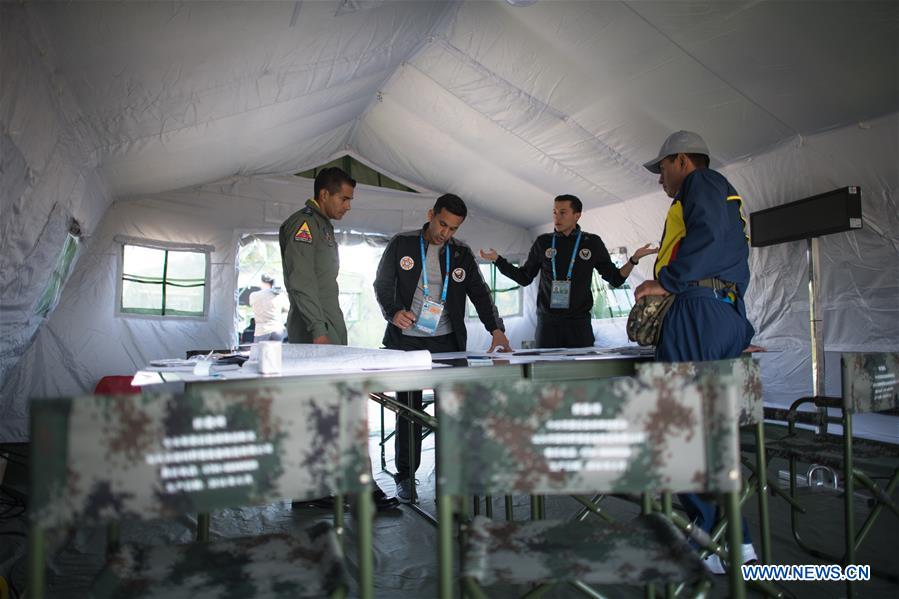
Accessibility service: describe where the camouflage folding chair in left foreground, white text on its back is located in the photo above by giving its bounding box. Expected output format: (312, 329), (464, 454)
(29, 384), (372, 598)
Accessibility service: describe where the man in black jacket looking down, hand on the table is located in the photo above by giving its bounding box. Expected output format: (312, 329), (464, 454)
(374, 194), (511, 503)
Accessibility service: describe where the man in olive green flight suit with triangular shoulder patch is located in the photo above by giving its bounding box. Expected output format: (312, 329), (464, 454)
(278, 167), (399, 512)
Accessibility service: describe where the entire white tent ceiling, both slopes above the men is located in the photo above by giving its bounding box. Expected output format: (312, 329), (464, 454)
(28, 0), (899, 226)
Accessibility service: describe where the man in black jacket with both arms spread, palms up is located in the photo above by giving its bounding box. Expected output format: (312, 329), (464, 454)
(481, 194), (659, 347)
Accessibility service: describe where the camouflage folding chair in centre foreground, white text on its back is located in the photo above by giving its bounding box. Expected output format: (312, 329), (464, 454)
(437, 366), (744, 598)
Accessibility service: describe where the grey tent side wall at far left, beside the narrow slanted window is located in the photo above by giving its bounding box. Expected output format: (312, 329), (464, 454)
(0, 5), (109, 410)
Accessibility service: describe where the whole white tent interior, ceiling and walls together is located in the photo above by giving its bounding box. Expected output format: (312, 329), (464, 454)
(0, 0), (899, 442)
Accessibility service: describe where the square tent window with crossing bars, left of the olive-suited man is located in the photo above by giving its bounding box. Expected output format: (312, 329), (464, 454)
(119, 244), (209, 317)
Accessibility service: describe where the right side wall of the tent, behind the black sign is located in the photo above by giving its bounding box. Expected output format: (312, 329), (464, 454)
(544, 113), (899, 442)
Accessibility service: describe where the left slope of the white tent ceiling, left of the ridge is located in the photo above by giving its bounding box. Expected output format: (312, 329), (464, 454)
(30, 2), (454, 197)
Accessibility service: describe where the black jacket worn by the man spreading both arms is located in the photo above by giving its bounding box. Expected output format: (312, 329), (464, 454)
(495, 225), (625, 318)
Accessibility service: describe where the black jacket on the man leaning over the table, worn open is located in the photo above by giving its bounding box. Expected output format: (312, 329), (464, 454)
(374, 224), (505, 350)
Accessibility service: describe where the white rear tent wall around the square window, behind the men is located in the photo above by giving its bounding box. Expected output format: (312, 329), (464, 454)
(0, 177), (533, 441)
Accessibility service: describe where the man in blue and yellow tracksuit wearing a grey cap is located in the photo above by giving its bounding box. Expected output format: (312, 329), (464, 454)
(634, 131), (755, 573)
